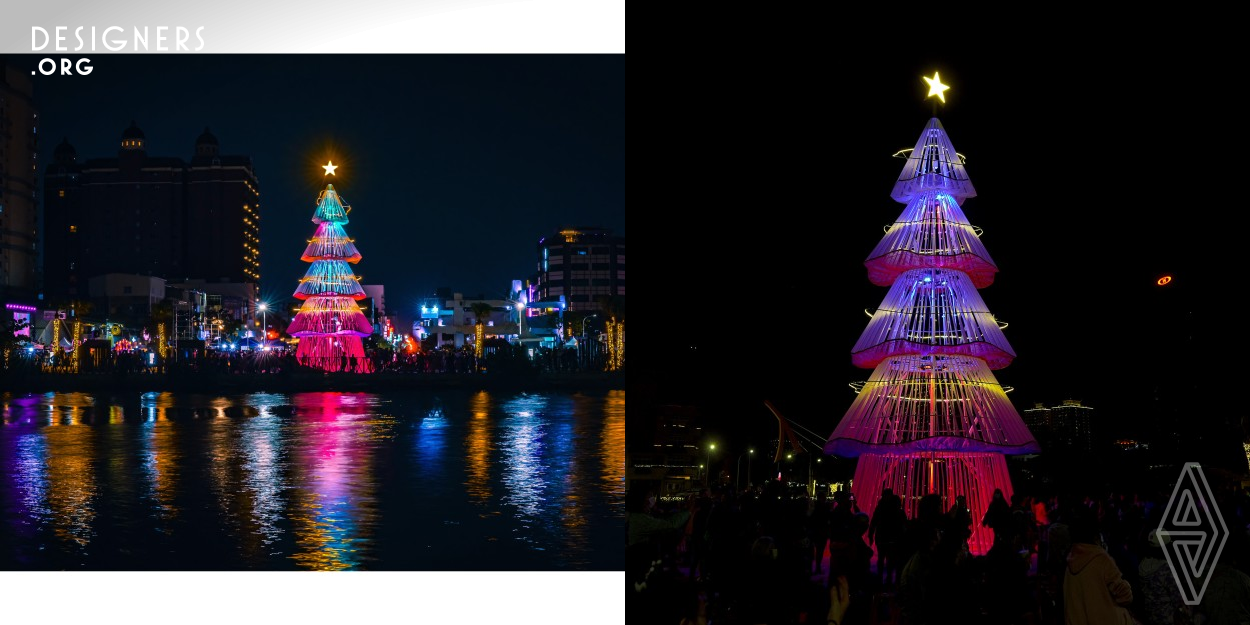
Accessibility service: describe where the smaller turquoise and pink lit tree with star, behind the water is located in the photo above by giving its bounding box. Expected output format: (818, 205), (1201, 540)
(286, 163), (374, 373)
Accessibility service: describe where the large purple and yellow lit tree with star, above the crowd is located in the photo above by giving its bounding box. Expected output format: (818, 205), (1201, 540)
(825, 74), (1039, 554)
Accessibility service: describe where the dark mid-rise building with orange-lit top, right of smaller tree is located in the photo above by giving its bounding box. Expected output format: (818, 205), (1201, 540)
(530, 228), (625, 313)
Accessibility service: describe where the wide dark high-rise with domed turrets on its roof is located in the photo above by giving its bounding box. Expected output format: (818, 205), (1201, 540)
(43, 121), (261, 301)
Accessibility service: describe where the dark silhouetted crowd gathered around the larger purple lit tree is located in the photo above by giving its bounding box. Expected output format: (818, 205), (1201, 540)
(626, 481), (1250, 625)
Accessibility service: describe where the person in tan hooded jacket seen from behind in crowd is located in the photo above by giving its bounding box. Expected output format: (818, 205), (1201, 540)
(1064, 515), (1134, 625)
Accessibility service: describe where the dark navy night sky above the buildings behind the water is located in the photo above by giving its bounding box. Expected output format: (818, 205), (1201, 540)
(17, 55), (625, 328)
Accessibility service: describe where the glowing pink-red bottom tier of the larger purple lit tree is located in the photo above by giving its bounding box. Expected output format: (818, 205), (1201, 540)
(851, 453), (1011, 555)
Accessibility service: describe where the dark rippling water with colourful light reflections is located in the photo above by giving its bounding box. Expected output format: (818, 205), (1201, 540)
(0, 390), (625, 570)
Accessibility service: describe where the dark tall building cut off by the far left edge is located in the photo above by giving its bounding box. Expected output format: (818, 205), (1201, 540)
(0, 59), (39, 305)
